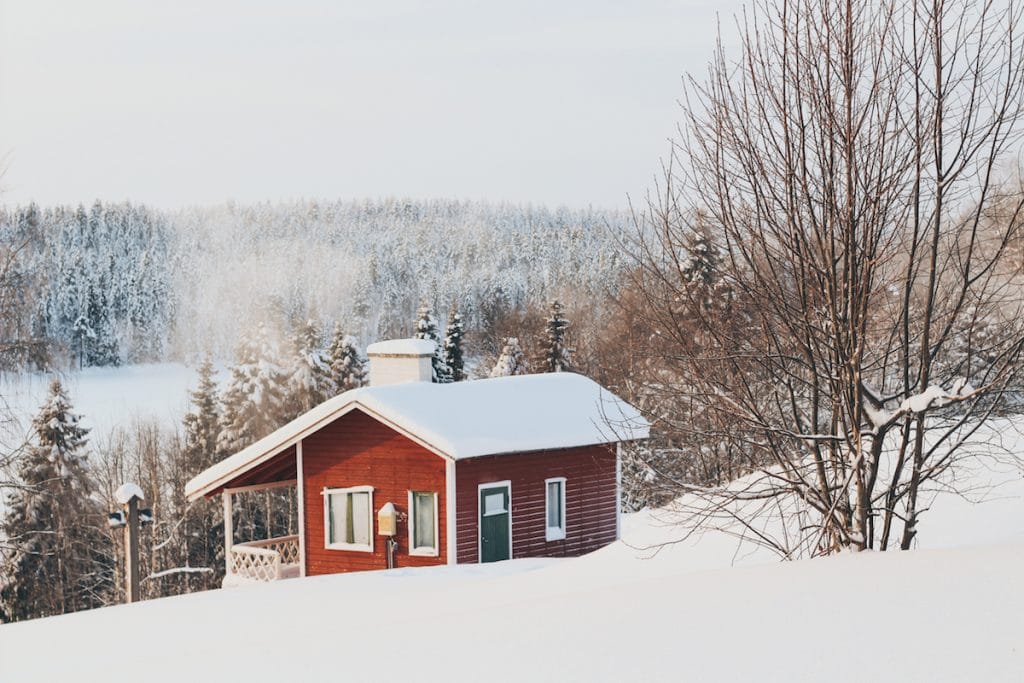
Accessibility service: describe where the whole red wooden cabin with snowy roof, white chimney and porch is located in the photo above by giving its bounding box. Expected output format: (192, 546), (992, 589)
(185, 340), (648, 584)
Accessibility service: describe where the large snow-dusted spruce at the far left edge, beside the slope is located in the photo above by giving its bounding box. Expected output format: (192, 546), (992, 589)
(0, 380), (114, 621)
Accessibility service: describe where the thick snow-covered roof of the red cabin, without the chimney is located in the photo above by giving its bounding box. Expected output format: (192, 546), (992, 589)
(185, 373), (650, 500)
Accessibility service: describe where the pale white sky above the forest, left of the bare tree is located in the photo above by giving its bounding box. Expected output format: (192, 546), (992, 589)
(0, 0), (738, 208)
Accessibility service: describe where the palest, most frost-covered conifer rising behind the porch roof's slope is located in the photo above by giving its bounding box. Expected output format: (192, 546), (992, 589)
(217, 324), (286, 457)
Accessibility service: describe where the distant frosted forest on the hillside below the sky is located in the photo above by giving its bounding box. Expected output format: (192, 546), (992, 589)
(0, 200), (628, 368)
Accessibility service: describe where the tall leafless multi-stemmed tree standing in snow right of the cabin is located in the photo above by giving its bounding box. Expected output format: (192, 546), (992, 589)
(630, 0), (1024, 557)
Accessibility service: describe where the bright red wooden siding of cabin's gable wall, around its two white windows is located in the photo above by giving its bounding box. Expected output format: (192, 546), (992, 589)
(302, 411), (446, 575)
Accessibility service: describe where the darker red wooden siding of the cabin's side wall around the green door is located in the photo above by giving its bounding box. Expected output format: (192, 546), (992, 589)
(456, 445), (617, 563)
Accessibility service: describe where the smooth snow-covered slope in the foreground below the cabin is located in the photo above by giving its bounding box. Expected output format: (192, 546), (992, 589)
(0, 423), (1024, 682)
